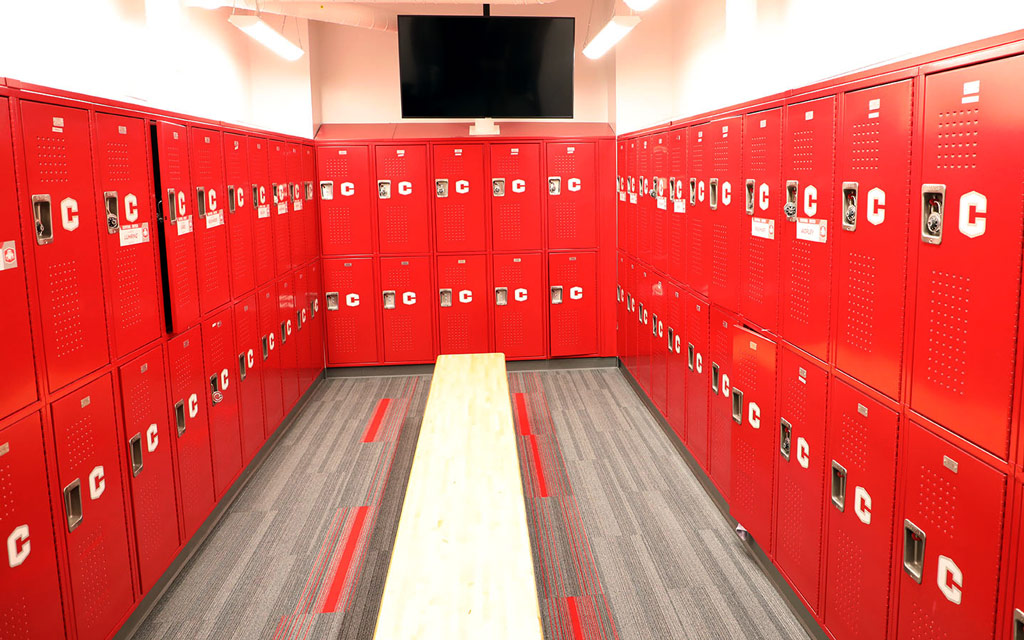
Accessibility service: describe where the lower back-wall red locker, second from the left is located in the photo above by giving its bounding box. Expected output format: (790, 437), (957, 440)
(380, 258), (434, 362)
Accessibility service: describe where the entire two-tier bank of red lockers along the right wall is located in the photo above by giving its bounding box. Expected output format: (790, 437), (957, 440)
(617, 56), (1024, 640)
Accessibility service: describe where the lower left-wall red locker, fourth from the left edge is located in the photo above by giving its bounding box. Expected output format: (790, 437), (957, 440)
(167, 327), (214, 541)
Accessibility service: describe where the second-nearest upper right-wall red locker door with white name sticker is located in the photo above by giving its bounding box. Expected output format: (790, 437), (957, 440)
(735, 109), (783, 331)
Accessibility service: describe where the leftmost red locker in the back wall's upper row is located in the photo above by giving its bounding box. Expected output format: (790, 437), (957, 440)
(316, 145), (374, 255)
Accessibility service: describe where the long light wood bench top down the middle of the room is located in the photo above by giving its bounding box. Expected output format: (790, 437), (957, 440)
(374, 353), (544, 640)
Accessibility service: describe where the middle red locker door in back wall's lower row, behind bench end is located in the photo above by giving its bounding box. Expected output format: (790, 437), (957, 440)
(437, 256), (490, 353)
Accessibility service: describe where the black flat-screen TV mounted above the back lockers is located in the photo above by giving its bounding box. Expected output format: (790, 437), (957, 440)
(395, 15), (575, 118)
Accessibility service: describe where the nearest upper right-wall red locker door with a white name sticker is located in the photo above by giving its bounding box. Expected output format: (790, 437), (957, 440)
(779, 96), (837, 360)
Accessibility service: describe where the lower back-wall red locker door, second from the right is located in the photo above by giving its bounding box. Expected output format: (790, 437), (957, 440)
(494, 253), (546, 360)
